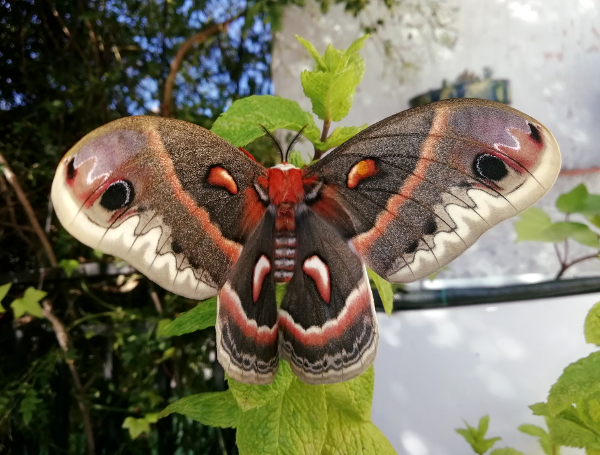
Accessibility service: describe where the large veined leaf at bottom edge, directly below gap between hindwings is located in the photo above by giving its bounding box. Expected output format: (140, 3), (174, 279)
(236, 361), (328, 455)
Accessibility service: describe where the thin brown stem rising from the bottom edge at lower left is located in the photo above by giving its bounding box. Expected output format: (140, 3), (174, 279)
(42, 300), (96, 455)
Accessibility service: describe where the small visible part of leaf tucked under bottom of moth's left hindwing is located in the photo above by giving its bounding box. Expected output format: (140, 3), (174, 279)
(227, 361), (295, 411)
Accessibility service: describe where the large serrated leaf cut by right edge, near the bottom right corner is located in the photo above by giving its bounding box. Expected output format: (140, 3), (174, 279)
(548, 352), (600, 416)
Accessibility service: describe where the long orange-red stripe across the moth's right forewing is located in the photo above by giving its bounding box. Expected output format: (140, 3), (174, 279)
(351, 109), (450, 255)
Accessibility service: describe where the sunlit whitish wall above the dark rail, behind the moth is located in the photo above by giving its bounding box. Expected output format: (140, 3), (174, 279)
(272, 0), (600, 278)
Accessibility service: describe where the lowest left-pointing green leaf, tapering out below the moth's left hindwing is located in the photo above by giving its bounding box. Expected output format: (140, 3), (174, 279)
(159, 390), (241, 428)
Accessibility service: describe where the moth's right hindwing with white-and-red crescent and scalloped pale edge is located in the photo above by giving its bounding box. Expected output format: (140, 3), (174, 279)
(279, 205), (378, 384)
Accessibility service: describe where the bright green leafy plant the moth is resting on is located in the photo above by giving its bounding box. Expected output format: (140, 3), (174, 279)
(155, 36), (395, 454)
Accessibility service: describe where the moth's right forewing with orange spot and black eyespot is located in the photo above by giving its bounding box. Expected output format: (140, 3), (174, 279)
(304, 99), (560, 282)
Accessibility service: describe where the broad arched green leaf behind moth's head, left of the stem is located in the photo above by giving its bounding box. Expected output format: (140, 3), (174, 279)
(211, 95), (321, 147)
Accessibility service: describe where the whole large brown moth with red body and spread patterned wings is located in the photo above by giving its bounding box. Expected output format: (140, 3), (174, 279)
(52, 99), (561, 384)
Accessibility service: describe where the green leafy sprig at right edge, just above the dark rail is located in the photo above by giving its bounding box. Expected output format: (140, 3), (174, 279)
(515, 183), (600, 279)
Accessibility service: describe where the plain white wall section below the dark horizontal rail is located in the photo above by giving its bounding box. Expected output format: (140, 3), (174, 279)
(372, 294), (600, 455)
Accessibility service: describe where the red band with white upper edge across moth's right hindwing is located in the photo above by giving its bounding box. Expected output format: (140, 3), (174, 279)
(279, 281), (372, 346)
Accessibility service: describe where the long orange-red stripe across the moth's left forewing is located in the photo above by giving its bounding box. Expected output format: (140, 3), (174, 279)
(148, 130), (242, 262)
